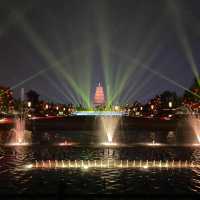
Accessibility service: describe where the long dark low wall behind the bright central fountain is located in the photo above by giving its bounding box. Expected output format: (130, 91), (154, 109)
(27, 116), (179, 131)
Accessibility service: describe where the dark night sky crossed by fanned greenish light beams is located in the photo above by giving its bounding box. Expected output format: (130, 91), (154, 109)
(0, 0), (200, 103)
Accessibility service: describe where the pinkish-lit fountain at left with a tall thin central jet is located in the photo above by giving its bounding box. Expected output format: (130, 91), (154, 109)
(6, 88), (31, 146)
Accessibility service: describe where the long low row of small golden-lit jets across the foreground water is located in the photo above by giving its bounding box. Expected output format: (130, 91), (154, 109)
(24, 160), (200, 169)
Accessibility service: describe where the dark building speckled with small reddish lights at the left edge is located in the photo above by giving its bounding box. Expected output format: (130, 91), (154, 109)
(0, 86), (14, 113)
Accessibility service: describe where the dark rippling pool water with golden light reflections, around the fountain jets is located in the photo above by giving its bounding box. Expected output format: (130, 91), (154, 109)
(0, 131), (200, 193)
